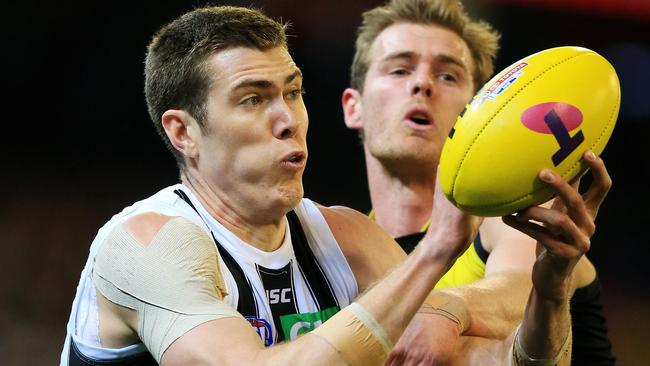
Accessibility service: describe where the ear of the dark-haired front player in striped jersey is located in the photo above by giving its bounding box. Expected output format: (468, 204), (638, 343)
(161, 109), (201, 158)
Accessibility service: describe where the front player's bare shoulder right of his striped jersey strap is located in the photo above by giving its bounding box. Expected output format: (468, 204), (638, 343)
(318, 205), (406, 291)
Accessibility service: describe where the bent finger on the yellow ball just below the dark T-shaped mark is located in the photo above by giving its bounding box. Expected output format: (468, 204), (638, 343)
(539, 169), (595, 235)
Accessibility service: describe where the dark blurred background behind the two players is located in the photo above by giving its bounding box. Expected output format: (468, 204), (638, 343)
(0, 0), (650, 365)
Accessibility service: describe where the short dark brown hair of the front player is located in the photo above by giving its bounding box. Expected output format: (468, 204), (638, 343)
(145, 6), (287, 169)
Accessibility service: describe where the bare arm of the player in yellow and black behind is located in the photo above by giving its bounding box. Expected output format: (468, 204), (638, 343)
(382, 222), (535, 365)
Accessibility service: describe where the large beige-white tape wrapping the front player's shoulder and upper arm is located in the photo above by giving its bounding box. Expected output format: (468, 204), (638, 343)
(93, 218), (241, 362)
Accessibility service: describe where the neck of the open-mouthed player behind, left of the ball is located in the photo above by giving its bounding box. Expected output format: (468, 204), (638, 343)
(366, 149), (435, 237)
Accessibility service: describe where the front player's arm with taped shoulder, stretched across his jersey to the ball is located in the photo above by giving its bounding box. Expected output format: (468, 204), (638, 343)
(100, 204), (472, 365)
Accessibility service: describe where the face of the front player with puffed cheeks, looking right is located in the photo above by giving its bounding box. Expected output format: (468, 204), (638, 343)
(199, 47), (308, 214)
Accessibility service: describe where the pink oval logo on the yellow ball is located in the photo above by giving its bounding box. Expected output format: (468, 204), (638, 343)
(521, 102), (582, 134)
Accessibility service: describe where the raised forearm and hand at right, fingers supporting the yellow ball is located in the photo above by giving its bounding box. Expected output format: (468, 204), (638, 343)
(448, 152), (611, 365)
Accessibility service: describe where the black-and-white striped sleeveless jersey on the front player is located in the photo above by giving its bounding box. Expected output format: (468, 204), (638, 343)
(60, 184), (359, 366)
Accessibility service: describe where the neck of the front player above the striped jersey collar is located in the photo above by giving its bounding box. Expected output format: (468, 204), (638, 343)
(181, 172), (286, 252)
